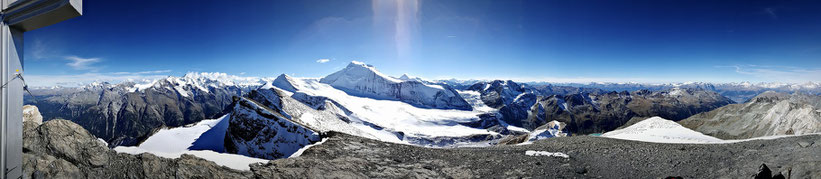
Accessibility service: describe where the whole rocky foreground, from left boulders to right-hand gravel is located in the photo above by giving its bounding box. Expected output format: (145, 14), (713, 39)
(24, 120), (821, 178)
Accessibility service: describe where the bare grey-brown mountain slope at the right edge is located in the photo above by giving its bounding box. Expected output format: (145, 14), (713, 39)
(679, 91), (821, 139)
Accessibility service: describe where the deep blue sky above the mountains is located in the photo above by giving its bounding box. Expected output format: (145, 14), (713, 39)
(19, 0), (821, 85)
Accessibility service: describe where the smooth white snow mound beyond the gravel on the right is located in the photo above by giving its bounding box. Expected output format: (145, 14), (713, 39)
(601, 117), (722, 143)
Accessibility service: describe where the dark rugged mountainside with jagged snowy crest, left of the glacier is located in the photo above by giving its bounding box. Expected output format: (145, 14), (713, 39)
(29, 80), (246, 147)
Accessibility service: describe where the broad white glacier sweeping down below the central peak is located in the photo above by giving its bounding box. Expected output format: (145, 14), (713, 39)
(260, 75), (499, 147)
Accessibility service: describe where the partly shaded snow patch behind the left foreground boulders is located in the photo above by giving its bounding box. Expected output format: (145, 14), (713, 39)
(114, 116), (268, 170)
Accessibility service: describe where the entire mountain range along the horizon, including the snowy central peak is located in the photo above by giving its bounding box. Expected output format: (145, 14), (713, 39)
(26, 62), (821, 150)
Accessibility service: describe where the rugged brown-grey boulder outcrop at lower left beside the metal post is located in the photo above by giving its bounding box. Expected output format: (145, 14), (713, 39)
(23, 119), (251, 178)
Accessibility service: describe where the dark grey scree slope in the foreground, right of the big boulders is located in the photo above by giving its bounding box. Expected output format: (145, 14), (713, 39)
(251, 133), (821, 178)
